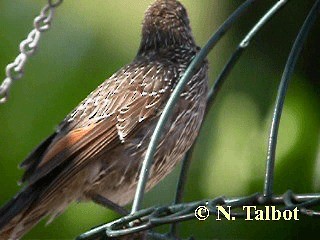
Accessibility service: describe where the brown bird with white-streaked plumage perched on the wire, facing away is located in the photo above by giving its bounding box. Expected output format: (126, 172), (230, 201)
(0, 0), (208, 239)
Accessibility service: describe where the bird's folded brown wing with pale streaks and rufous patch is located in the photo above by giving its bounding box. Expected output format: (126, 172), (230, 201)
(21, 59), (178, 184)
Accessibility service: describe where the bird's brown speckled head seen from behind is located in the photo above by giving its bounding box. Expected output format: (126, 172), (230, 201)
(139, 0), (195, 53)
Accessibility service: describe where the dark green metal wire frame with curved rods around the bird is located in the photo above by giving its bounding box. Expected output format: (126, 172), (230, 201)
(78, 0), (320, 239)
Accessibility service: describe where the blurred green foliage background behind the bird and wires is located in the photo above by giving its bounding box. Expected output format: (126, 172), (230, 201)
(0, 0), (320, 239)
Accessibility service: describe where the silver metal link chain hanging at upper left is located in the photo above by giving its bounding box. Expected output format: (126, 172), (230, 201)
(0, 0), (63, 104)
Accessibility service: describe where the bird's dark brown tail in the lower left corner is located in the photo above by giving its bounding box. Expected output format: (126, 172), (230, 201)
(0, 186), (46, 240)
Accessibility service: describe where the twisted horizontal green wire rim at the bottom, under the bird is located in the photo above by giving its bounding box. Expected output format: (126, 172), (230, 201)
(77, 191), (320, 240)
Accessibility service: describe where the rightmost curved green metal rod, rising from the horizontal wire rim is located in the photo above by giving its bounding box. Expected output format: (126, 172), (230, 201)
(263, 0), (320, 201)
